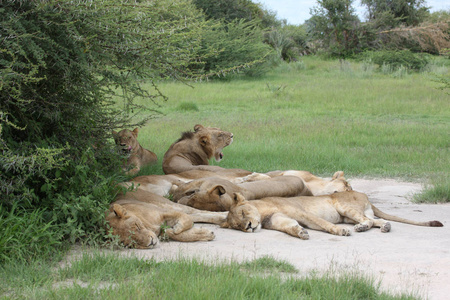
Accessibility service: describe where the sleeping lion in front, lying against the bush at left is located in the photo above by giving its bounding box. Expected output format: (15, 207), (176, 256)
(106, 190), (226, 249)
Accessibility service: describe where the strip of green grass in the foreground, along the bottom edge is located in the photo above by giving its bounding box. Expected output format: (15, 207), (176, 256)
(0, 251), (415, 300)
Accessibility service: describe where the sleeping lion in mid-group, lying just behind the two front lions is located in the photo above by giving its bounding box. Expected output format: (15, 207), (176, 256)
(173, 176), (312, 211)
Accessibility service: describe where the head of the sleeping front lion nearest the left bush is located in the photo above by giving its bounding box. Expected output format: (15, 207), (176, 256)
(106, 204), (159, 249)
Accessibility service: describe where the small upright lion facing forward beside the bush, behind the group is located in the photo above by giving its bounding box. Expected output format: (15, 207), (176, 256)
(112, 128), (158, 175)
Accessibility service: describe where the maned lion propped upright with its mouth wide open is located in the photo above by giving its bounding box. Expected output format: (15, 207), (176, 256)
(162, 124), (252, 177)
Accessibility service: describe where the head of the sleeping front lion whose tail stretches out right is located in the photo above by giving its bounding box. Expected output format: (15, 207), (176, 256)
(220, 193), (261, 232)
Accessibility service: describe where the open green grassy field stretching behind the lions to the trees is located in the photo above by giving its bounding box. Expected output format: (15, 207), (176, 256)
(135, 57), (450, 200)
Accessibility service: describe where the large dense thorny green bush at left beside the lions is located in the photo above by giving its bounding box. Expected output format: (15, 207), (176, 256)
(0, 0), (209, 260)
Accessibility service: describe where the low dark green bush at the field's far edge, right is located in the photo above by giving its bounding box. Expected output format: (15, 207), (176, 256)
(361, 50), (430, 71)
